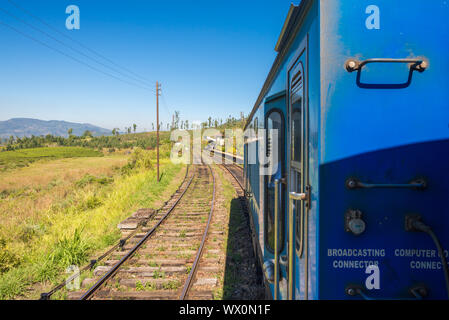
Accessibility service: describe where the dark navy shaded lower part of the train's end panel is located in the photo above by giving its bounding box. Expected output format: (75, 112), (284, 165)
(320, 140), (449, 299)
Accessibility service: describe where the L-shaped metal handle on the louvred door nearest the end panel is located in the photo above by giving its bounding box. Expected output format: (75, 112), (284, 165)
(287, 192), (307, 300)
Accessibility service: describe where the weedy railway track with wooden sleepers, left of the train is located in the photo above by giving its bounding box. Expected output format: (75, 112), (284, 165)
(69, 165), (221, 300)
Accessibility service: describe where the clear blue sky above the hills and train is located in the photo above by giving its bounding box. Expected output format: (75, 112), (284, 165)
(0, 0), (299, 130)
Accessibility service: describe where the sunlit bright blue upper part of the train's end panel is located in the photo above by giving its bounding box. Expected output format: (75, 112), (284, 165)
(320, 0), (449, 162)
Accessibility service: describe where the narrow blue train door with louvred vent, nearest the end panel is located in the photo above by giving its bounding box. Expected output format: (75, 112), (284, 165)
(287, 38), (310, 299)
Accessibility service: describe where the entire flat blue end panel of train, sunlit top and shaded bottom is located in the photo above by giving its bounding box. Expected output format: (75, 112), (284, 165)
(319, 0), (449, 299)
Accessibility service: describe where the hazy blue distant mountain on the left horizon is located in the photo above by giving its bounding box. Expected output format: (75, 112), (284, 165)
(0, 118), (111, 139)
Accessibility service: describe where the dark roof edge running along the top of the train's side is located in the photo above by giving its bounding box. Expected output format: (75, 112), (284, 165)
(245, 0), (313, 129)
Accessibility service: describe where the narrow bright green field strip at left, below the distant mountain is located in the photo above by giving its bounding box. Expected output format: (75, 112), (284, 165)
(0, 147), (103, 170)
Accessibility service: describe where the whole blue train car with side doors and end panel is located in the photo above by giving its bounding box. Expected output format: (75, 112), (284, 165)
(244, 0), (449, 299)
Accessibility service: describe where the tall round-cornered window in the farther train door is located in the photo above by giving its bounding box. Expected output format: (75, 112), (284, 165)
(264, 110), (285, 252)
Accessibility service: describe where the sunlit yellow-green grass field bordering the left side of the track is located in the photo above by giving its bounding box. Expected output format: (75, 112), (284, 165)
(0, 146), (183, 299)
